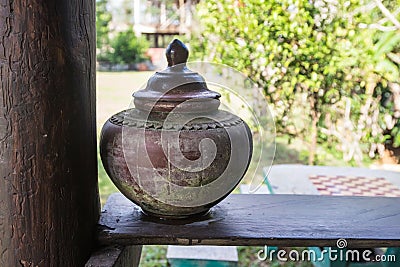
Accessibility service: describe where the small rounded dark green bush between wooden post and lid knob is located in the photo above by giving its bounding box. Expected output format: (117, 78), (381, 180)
(108, 30), (149, 64)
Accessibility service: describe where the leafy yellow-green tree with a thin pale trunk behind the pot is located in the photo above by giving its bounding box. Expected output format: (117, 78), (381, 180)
(191, 0), (366, 163)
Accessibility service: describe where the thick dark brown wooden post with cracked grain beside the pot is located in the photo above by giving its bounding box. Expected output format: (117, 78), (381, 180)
(0, 0), (99, 266)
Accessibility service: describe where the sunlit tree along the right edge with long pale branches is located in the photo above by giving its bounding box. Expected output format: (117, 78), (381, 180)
(322, 0), (400, 158)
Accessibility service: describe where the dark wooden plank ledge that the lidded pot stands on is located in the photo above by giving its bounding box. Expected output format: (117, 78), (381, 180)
(99, 193), (400, 248)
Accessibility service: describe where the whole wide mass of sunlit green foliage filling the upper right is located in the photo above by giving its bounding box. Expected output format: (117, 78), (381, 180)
(191, 0), (400, 163)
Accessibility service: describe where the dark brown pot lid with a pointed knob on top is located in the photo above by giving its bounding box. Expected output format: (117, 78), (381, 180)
(133, 39), (221, 112)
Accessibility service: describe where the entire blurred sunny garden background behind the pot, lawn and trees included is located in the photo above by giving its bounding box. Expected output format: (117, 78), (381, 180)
(96, 0), (400, 266)
